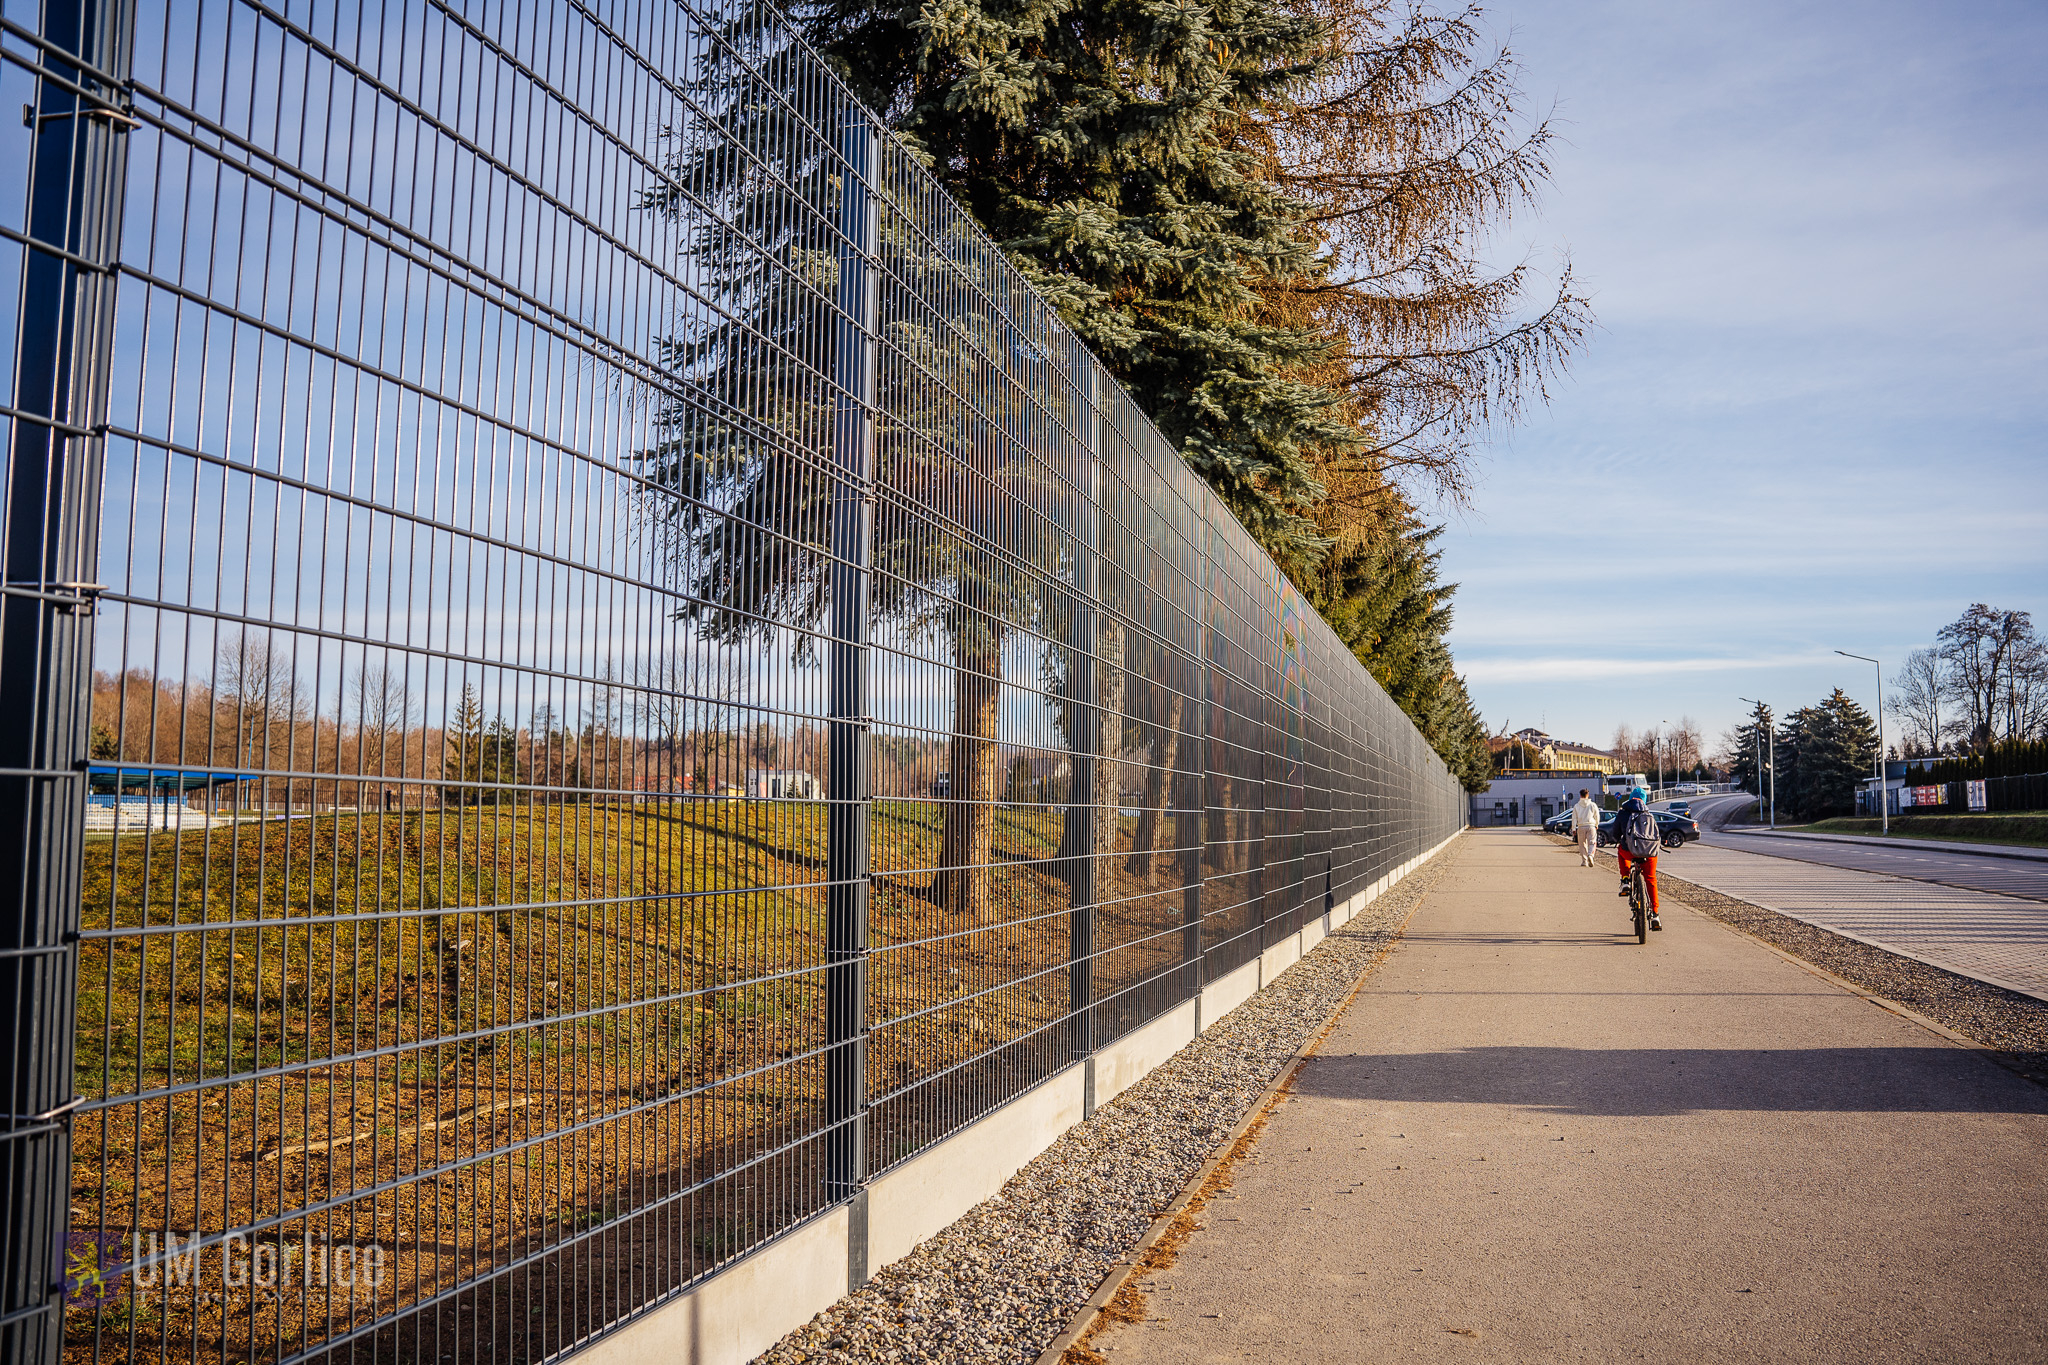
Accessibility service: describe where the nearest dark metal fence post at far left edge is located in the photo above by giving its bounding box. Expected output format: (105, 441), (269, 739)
(0, 0), (127, 1361)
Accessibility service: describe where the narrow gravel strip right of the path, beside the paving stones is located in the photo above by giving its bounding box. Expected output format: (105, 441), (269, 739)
(1559, 839), (2048, 1085)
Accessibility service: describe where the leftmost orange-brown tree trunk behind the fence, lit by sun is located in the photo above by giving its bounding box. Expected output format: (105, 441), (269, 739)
(932, 622), (1001, 923)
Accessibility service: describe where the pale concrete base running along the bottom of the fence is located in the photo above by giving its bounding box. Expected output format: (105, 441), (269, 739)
(578, 831), (1462, 1365)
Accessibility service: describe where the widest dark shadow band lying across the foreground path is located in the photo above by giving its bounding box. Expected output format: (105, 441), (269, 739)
(1294, 1048), (2048, 1117)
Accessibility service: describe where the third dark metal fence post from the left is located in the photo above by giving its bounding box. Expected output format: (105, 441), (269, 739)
(1061, 370), (1102, 1064)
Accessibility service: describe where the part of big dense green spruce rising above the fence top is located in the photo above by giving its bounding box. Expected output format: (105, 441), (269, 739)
(795, 0), (1360, 563)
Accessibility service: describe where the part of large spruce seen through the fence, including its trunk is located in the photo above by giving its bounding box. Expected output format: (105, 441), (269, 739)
(641, 56), (1073, 919)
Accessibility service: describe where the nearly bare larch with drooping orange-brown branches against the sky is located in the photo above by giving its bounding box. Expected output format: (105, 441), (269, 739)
(1239, 0), (1591, 509)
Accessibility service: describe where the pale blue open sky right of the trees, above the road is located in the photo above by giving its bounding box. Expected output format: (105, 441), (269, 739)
(1442, 0), (2048, 757)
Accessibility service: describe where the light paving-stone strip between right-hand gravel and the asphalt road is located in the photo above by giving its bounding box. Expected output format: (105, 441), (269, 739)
(1657, 843), (2048, 1001)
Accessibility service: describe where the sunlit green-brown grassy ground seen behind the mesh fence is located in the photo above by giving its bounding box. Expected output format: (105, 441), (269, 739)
(72, 800), (1182, 1359)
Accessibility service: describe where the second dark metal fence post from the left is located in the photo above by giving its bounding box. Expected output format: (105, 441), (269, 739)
(825, 112), (879, 1244)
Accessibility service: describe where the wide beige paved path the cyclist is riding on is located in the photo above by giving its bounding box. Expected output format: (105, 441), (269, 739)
(1098, 831), (2048, 1365)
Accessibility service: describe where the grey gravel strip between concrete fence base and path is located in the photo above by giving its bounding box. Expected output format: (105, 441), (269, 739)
(760, 845), (1458, 1365)
